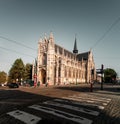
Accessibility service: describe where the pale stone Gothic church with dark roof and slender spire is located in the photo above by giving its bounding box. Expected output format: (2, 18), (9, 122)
(33, 33), (96, 85)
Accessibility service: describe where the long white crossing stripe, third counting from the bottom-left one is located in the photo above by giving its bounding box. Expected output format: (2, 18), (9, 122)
(44, 101), (99, 116)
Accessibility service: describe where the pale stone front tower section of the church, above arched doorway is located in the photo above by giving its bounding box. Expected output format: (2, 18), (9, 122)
(37, 33), (55, 85)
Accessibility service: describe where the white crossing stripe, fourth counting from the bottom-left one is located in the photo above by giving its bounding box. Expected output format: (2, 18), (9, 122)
(54, 99), (104, 110)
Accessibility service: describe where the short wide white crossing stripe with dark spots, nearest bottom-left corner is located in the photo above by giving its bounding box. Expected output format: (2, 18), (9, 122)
(7, 110), (42, 124)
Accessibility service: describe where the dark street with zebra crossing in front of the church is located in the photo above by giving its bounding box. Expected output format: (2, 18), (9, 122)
(0, 84), (120, 124)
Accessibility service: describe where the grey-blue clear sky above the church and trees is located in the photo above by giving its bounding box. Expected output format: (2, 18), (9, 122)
(0, 0), (120, 76)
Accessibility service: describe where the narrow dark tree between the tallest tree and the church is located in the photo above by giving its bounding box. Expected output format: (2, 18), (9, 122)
(25, 63), (32, 80)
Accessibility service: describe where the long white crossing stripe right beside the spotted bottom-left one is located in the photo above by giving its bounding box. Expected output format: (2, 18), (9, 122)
(29, 105), (92, 124)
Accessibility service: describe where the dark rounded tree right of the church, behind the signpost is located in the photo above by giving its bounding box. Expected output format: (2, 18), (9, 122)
(104, 68), (117, 83)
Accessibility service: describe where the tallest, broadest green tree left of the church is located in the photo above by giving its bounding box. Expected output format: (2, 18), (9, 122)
(8, 58), (25, 82)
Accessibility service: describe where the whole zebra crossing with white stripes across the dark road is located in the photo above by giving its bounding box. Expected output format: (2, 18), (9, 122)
(7, 93), (111, 124)
